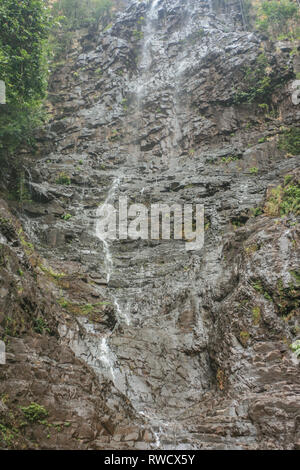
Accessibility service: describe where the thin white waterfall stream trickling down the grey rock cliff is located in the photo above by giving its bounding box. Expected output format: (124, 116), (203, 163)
(96, 0), (199, 449)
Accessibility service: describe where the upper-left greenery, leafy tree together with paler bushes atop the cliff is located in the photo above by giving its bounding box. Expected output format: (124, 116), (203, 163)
(0, 0), (119, 156)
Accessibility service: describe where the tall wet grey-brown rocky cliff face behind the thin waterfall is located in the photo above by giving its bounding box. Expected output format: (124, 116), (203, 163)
(0, 0), (300, 449)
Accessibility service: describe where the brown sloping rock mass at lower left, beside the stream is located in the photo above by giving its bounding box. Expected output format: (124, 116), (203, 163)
(0, 200), (151, 449)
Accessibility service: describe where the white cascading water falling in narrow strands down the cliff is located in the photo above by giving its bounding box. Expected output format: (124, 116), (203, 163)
(101, 0), (202, 449)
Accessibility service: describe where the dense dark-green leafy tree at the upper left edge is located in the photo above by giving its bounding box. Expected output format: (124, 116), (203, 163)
(0, 0), (51, 155)
